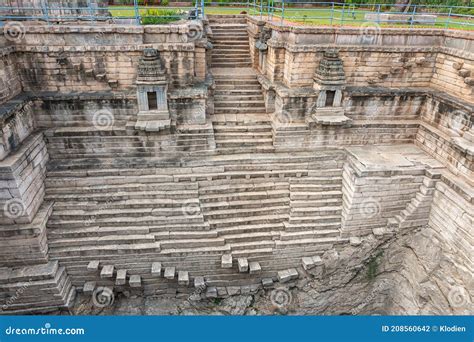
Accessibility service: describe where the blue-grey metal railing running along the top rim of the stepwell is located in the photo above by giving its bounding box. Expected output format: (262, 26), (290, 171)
(0, 0), (474, 29)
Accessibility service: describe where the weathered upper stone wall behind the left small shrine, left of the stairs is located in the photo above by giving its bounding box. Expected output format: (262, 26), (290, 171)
(9, 24), (206, 92)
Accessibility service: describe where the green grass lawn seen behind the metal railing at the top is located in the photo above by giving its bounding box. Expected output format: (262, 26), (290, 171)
(109, 5), (474, 30)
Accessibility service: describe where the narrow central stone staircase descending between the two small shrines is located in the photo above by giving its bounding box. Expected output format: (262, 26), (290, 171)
(209, 16), (274, 154)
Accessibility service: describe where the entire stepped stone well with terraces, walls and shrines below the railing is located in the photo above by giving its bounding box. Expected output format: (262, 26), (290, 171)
(0, 15), (474, 315)
